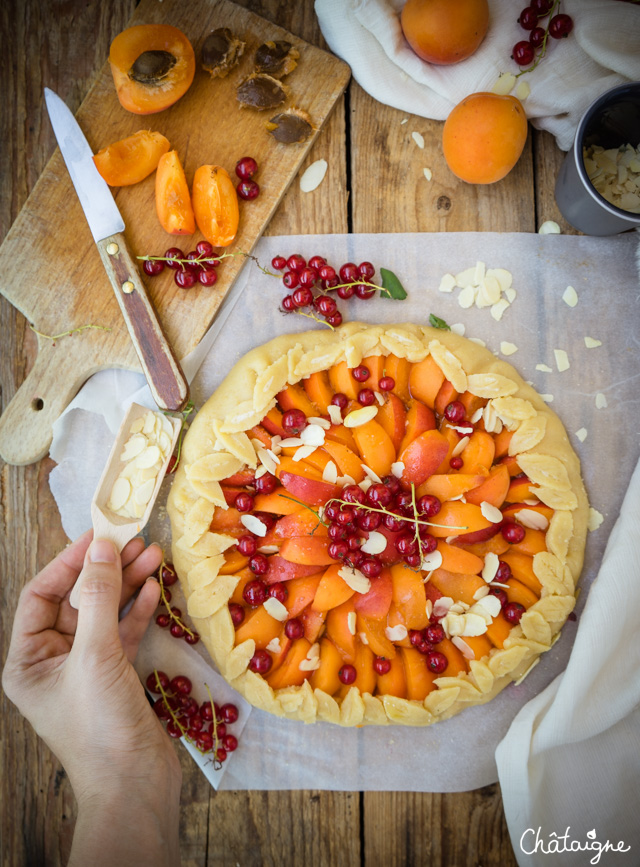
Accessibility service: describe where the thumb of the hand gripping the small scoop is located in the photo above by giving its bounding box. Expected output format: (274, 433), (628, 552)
(73, 539), (122, 653)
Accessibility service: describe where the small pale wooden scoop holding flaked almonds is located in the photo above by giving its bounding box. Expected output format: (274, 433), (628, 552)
(69, 403), (182, 608)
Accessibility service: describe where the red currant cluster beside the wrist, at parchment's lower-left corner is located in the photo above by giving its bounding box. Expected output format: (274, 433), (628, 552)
(146, 670), (238, 768)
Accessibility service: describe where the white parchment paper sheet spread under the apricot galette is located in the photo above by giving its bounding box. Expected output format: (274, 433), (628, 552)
(51, 233), (640, 792)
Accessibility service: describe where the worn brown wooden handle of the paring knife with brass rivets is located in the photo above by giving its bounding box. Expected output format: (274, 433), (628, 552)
(98, 232), (189, 411)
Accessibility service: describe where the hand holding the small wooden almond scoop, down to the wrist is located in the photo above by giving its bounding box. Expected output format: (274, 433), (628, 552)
(2, 532), (180, 803)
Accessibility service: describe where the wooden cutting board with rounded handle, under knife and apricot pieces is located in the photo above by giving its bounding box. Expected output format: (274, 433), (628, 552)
(0, 0), (350, 464)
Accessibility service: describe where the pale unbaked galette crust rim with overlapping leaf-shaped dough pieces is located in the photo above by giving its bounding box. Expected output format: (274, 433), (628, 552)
(167, 322), (588, 726)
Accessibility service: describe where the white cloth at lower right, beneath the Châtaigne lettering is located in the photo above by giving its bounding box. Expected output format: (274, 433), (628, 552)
(496, 463), (640, 867)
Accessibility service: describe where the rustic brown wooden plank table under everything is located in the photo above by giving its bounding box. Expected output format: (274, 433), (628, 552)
(0, 0), (571, 867)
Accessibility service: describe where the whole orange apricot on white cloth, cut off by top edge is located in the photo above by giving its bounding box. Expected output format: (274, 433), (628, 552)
(400, 0), (489, 66)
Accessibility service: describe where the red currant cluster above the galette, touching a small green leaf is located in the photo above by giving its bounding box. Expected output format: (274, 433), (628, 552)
(271, 253), (380, 328)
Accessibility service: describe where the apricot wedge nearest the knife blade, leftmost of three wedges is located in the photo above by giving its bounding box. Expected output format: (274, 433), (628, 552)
(93, 129), (170, 187)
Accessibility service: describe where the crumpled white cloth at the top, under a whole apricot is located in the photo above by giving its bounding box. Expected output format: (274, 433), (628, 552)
(315, 0), (640, 151)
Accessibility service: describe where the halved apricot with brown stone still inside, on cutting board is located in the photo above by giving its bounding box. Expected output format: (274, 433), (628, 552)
(109, 24), (196, 114)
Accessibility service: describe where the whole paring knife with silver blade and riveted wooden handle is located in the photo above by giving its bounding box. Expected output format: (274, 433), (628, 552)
(44, 87), (189, 410)
